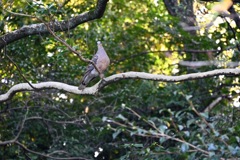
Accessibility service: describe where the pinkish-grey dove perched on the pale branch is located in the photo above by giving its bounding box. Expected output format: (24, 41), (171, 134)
(78, 41), (110, 90)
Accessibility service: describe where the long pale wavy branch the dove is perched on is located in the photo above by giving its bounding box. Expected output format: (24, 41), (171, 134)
(0, 69), (240, 102)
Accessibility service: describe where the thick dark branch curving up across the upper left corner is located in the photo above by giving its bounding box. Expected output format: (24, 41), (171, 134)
(0, 0), (108, 49)
